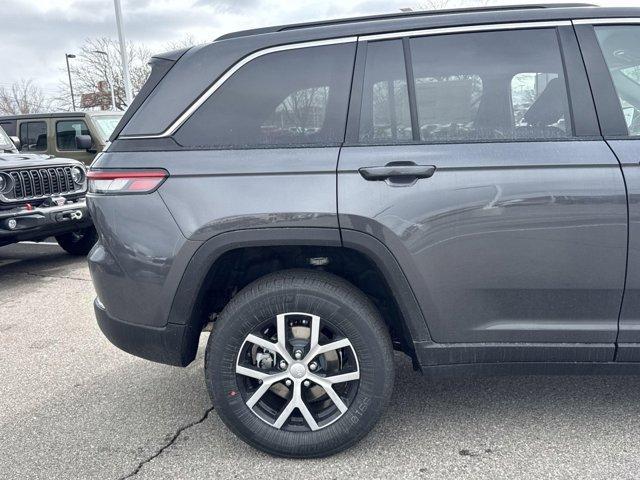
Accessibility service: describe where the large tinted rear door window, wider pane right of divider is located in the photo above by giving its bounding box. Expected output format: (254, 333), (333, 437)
(411, 29), (571, 142)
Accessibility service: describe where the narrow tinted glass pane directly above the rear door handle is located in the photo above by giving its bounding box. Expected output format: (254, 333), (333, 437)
(360, 40), (412, 143)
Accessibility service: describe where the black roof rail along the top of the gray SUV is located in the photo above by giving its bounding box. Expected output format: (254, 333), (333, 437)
(216, 3), (598, 40)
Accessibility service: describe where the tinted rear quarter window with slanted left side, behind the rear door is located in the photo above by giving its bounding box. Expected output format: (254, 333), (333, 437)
(175, 44), (355, 148)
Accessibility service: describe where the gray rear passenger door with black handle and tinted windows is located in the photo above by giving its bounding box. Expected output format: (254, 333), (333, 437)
(338, 22), (627, 348)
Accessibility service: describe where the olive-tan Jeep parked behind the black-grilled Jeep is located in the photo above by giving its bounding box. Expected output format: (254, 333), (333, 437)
(0, 111), (122, 165)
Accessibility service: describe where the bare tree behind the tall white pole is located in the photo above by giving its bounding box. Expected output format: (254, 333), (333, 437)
(59, 37), (151, 110)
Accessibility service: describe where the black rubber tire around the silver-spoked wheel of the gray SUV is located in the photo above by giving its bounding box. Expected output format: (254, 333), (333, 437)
(205, 270), (394, 458)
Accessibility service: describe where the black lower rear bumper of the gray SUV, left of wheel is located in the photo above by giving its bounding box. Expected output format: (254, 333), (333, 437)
(93, 298), (200, 367)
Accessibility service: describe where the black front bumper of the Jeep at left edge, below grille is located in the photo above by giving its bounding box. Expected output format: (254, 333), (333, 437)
(0, 199), (92, 245)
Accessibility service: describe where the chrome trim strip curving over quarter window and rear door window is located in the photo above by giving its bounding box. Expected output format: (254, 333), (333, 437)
(118, 20), (572, 140)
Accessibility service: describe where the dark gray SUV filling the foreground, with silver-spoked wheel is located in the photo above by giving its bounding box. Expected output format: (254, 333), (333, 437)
(88, 5), (640, 457)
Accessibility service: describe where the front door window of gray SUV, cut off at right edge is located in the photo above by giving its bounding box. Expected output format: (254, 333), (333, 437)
(596, 26), (640, 136)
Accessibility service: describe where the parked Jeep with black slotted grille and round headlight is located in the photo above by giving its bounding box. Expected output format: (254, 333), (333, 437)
(0, 127), (97, 255)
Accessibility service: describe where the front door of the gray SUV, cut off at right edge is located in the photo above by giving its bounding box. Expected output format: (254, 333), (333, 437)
(576, 19), (640, 362)
